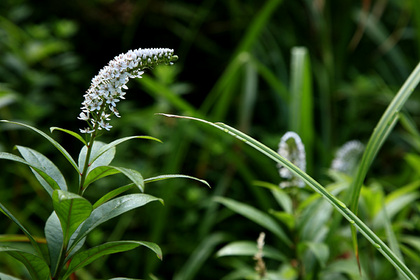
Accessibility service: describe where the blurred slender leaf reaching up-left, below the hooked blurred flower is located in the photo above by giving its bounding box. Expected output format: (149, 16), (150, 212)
(216, 197), (292, 246)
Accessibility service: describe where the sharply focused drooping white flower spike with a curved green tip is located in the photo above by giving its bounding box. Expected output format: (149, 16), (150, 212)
(78, 48), (178, 133)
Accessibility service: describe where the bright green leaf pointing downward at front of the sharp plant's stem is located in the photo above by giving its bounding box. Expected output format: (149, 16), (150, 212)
(53, 190), (92, 243)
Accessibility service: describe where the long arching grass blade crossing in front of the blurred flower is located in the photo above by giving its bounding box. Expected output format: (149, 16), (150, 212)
(162, 113), (420, 280)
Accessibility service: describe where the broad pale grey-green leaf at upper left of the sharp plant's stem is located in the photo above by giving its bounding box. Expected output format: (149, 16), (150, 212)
(16, 146), (67, 191)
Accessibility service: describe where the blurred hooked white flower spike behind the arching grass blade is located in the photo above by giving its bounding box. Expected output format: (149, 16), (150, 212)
(277, 131), (306, 188)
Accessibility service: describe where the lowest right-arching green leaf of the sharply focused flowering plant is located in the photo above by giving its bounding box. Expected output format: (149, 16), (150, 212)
(63, 241), (162, 280)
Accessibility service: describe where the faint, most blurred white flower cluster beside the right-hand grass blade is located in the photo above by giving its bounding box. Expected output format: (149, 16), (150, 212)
(331, 140), (365, 175)
